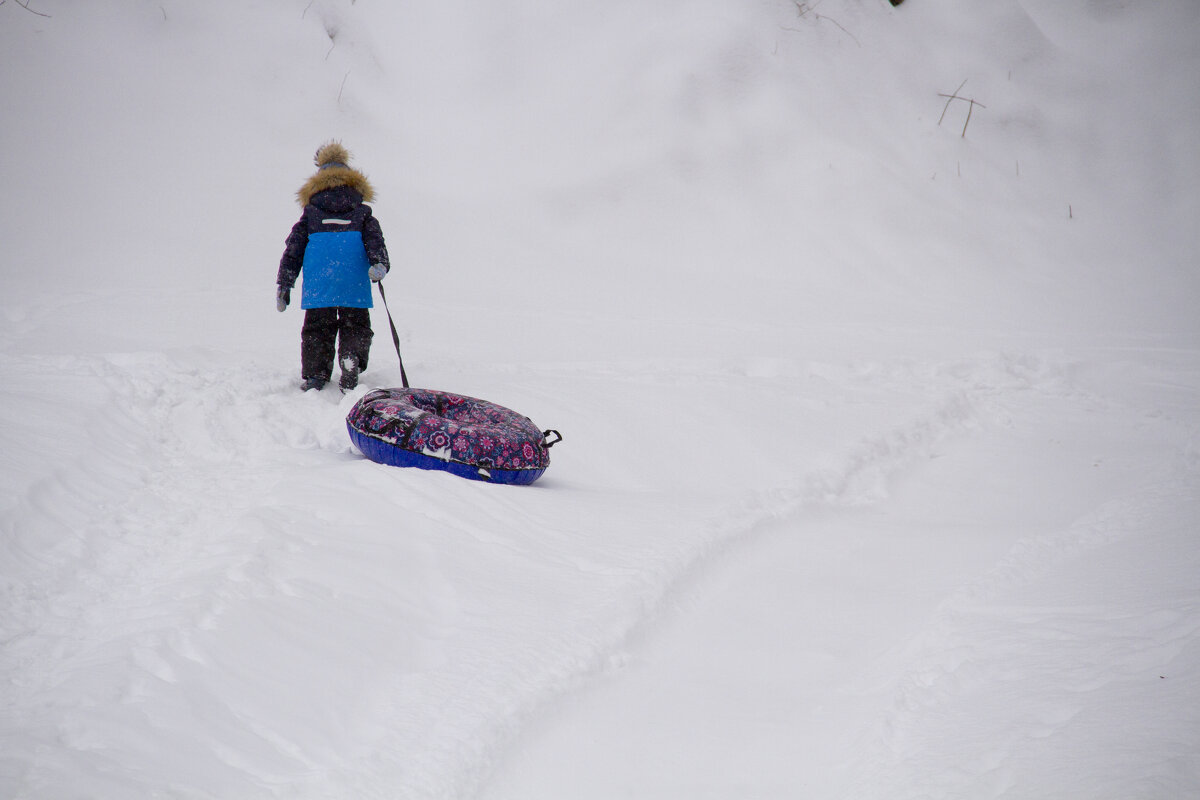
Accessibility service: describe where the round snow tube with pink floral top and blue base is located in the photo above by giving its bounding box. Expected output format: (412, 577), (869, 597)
(346, 389), (563, 485)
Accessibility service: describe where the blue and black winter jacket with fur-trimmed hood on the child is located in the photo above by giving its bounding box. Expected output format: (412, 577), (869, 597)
(277, 155), (390, 308)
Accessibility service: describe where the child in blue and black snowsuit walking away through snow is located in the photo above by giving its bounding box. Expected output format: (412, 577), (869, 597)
(275, 142), (391, 391)
